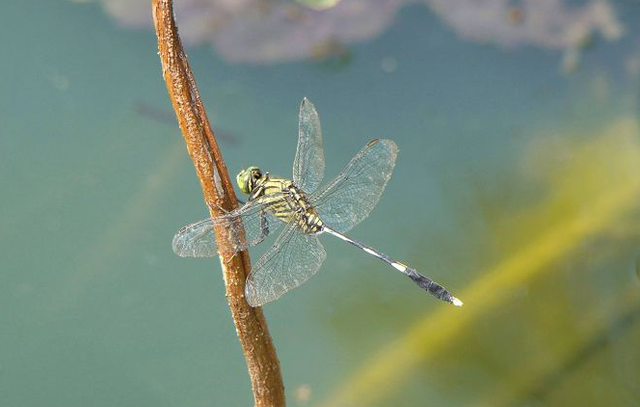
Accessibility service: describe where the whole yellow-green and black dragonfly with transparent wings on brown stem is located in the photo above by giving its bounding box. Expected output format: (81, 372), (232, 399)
(173, 98), (462, 307)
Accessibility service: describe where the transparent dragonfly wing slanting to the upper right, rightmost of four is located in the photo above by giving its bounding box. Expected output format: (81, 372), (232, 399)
(310, 140), (398, 233)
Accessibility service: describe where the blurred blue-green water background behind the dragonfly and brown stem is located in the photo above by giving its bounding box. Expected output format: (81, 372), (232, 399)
(0, 0), (640, 407)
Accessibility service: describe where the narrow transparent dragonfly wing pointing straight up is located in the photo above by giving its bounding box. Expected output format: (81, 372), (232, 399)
(293, 98), (324, 193)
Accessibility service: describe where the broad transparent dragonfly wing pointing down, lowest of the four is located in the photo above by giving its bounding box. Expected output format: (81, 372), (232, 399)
(245, 220), (327, 307)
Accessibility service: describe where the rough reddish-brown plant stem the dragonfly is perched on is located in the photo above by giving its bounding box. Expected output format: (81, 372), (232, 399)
(152, 0), (285, 407)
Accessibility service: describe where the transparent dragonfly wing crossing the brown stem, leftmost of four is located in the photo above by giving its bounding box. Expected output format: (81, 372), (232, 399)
(173, 194), (283, 257)
